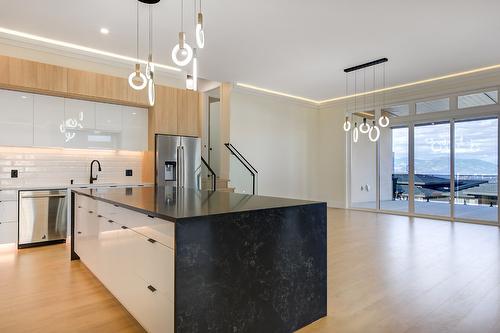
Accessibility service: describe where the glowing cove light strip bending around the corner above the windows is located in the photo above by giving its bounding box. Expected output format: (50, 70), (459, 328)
(236, 64), (500, 105)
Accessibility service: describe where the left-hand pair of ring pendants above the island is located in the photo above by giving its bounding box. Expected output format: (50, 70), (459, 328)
(128, 0), (159, 106)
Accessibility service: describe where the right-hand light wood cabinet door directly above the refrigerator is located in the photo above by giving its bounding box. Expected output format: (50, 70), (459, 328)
(177, 90), (200, 137)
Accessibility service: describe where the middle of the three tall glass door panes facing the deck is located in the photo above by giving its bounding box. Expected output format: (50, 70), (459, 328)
(413, 122), (451, 217)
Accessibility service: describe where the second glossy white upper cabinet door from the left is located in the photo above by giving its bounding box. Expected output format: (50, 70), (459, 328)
(34, 95), (65, 147)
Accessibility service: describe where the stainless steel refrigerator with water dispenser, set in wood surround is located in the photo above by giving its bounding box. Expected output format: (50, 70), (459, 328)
(155, 134), (201, 189)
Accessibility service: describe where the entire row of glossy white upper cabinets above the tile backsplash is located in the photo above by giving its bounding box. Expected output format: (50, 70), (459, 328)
(0, 89), (148, 151)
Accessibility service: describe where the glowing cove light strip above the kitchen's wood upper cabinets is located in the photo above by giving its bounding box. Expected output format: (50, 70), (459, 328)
(0, 27), (181, 72)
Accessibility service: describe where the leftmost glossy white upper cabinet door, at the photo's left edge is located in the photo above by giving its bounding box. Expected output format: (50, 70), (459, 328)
(0, 90), (33, 146)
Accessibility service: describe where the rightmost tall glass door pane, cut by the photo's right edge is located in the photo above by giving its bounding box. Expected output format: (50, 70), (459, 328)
(455, 118), (498, 221)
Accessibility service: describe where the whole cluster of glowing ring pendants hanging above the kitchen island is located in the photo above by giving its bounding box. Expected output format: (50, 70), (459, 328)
(128, 0), (205, 106)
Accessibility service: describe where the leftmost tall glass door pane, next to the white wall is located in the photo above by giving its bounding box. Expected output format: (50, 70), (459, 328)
(380, 127), (409, 212)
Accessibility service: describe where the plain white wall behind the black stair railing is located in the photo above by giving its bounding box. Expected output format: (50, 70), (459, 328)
(230, 89), (319, 199)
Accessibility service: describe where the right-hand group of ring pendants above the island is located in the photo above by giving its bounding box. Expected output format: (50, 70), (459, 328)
(172, 0), (205, 91)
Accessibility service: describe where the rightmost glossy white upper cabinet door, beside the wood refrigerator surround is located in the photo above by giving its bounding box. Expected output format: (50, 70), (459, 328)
(121, 107), (148, 151)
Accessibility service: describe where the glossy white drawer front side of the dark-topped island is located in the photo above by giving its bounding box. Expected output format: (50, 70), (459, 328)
(74, 194), (175, 333)
